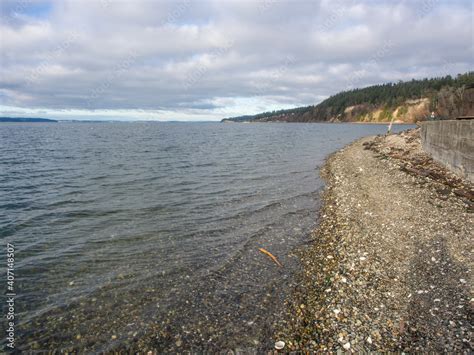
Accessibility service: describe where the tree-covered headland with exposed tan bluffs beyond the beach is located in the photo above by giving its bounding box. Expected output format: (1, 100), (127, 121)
(222, 72), (474, 123)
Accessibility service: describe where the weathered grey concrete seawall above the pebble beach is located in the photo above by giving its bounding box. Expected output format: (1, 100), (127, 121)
(421, 120), (474, 182)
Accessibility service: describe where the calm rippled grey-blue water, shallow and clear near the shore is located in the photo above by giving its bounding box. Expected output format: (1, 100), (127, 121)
(0, 123), (412, 351)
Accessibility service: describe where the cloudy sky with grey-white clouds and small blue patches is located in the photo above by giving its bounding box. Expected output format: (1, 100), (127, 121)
(0, 0), (474, 121)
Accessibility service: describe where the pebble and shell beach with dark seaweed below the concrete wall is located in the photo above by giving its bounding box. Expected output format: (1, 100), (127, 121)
(275, 129), (474, 353)
